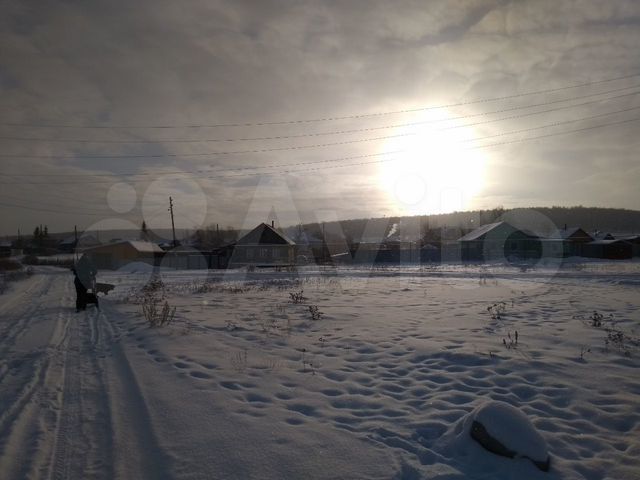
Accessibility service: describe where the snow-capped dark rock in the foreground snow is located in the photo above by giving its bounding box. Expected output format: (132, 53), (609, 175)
(469, 401), (550, 471)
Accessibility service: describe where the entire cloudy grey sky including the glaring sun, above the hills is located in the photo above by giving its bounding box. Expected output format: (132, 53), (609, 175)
(0, 0), (640, 238)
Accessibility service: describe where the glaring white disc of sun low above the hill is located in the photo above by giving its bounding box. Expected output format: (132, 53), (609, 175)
(379, 110), (486, 215)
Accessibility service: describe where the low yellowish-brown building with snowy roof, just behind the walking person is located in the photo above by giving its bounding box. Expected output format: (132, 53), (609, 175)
(85, 240), (164, 270)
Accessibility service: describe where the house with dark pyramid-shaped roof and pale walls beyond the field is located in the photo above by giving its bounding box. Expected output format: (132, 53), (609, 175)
(229, 223), (296, 267)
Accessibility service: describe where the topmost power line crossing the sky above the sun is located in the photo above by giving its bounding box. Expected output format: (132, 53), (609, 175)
(1, 73), (640, 129)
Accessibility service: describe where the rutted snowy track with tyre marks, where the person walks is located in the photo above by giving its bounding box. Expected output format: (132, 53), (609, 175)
(0, 270), (172, 480)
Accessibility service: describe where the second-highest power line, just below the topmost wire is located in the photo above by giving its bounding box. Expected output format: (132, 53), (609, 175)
(0, 85), (640, 145)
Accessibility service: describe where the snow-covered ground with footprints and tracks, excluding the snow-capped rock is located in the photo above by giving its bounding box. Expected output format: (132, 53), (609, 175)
(0, 263), (640, 480)
